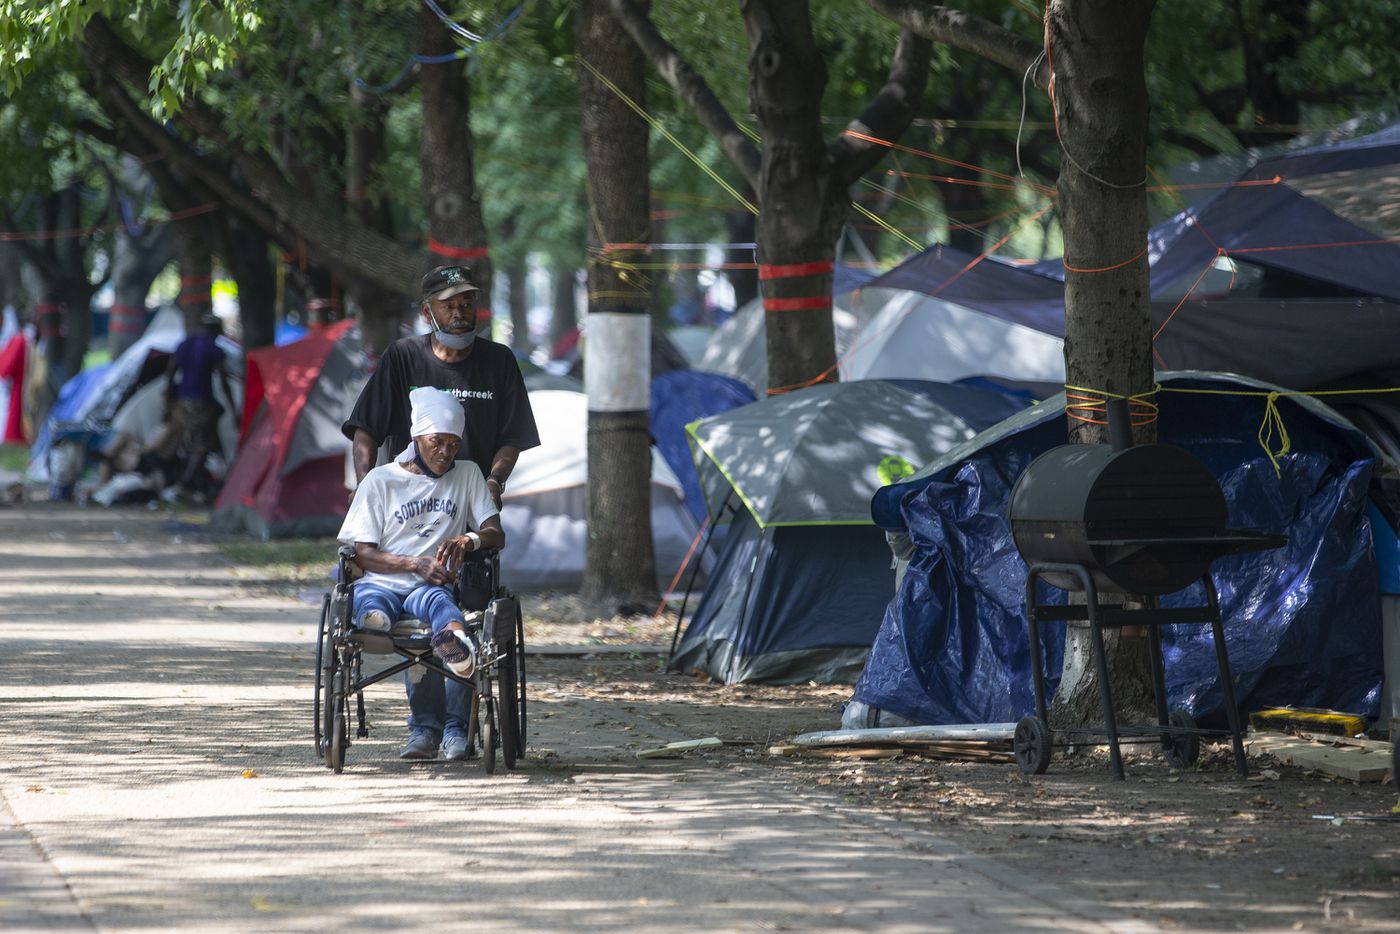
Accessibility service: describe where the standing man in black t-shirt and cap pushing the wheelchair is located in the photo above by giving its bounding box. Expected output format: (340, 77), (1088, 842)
(342, 266), (539, 759)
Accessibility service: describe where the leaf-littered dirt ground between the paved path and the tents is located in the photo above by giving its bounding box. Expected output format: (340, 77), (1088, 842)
(10, 507), (1400, 931)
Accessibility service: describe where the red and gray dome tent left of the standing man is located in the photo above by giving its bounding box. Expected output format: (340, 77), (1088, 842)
(211, 321), (368, 539)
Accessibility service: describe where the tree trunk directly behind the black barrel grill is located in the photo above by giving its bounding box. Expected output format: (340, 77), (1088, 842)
(1047, 0), (1155, 725)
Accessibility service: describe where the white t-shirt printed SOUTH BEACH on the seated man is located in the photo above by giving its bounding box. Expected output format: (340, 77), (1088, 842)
(336, 461), (497, 594)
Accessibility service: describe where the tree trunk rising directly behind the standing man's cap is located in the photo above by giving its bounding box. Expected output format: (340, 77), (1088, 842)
(417, 4), (491, 335)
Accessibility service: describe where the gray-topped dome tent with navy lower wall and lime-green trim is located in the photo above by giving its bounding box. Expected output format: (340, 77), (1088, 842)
(673, 379), (1016, 683)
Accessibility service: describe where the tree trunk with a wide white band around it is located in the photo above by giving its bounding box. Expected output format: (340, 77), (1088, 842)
(574, 0), (657, 604)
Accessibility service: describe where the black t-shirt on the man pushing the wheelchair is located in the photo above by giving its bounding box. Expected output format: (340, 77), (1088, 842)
(340, 335), (539, 475)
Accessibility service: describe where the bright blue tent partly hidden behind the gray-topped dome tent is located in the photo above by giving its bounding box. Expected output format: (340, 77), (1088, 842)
(651, 370), (753, 522)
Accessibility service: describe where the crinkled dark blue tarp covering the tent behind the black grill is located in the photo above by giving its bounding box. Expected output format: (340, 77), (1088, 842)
(855, 379), (1383, 725)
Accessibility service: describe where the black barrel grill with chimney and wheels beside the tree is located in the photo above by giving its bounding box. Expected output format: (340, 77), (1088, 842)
(1009, 399), (1288, 780)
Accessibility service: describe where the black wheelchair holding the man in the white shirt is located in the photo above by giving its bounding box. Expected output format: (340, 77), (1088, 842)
(314, 545), (525, 774)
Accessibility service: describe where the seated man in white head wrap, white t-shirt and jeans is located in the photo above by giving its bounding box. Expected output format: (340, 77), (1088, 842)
(336, 386), (505, 700)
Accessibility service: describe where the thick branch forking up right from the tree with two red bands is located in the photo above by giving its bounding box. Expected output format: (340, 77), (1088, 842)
(826, 29), (932, 186)
